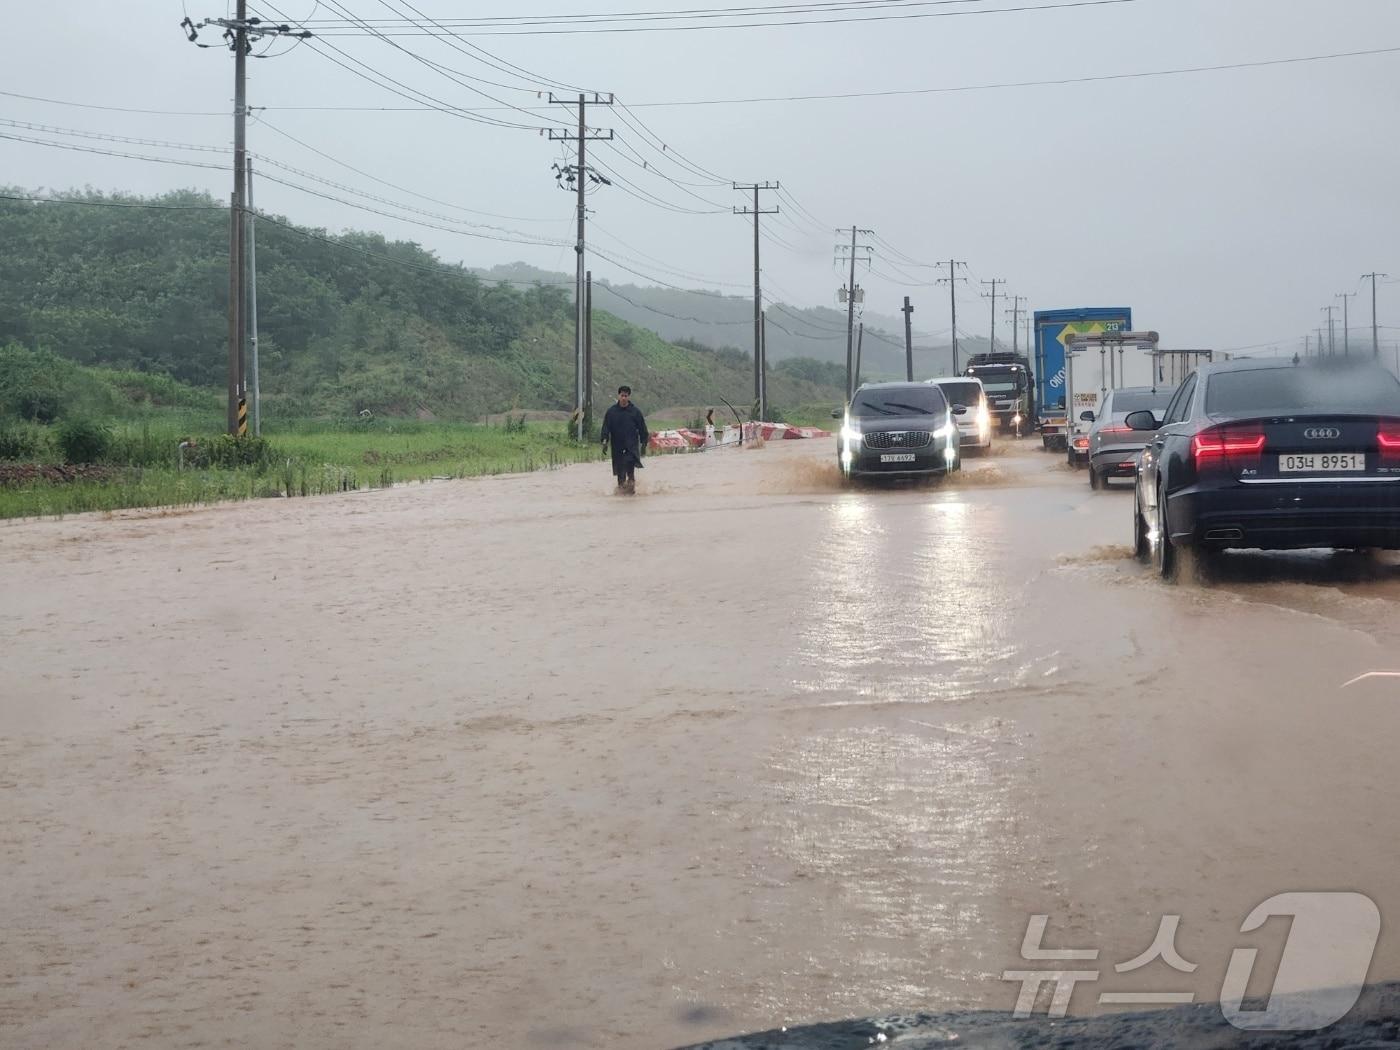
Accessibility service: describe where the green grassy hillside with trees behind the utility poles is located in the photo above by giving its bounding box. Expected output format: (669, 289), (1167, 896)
(0, 192), (840, 424)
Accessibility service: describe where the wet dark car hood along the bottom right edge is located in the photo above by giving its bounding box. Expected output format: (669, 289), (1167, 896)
(669, 981), (1400, 1050)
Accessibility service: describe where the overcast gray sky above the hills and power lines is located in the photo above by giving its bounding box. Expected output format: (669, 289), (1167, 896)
(0, 0), (1400, 350)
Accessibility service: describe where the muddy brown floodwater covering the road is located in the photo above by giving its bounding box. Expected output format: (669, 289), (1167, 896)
(0, 441), (1400, 1050)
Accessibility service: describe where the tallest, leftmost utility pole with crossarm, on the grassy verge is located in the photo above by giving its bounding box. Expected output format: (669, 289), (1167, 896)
(181, 0), (311, 435)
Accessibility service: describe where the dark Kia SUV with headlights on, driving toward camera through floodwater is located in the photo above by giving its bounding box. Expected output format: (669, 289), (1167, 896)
(837, 382), (967, 479)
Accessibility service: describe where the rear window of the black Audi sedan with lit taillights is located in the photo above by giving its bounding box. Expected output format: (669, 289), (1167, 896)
(1205, 365), (1400, 416)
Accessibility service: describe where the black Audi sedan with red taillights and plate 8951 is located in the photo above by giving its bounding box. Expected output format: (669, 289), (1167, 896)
(1124, 358), (1400, 578)
